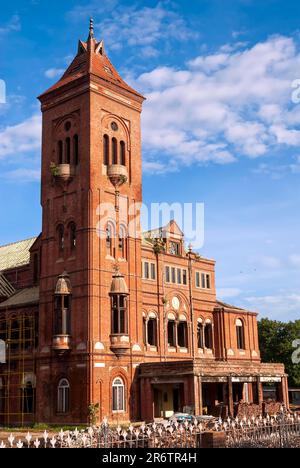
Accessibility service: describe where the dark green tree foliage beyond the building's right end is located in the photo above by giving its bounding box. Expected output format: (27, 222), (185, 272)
(258, 319), (300, 387)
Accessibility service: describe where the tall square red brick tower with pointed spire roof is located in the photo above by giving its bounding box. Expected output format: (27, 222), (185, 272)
(36, 20), (144, 423)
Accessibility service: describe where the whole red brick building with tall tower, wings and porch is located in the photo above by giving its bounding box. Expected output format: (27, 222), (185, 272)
(0, 23), (288, 425)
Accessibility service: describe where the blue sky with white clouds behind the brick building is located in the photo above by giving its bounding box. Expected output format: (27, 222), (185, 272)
(0, 0), (300, 320)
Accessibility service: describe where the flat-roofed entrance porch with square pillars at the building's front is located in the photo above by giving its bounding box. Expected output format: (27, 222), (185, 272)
(139, 360), (289, 422)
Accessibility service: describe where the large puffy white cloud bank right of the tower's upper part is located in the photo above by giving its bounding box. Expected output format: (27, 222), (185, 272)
(129, 36), (300, 172)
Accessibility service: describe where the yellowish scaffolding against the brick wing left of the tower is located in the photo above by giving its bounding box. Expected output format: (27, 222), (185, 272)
(0, 310), (37, 427)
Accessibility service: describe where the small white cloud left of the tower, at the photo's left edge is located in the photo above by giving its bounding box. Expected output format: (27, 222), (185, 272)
(0, 115), (42, 160)
